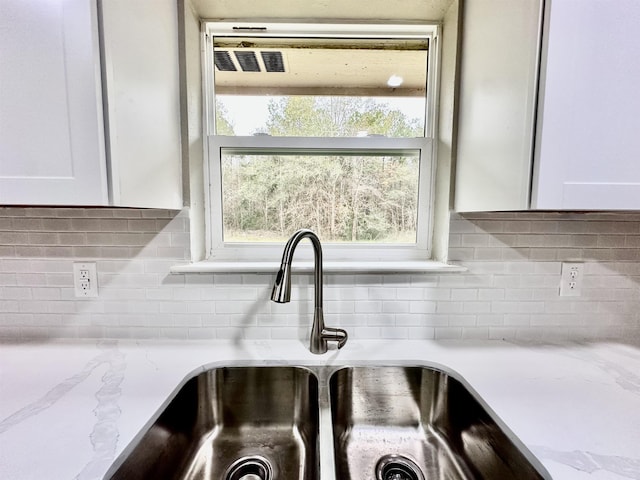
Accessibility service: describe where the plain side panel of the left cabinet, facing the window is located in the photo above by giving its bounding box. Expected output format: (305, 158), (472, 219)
(102, 0), (182, 209)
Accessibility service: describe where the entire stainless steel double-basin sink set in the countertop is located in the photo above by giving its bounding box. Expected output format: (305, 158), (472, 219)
(105, 365), (551, 480)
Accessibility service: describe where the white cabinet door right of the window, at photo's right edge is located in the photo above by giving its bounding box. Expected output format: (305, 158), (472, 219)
(532, 0), (640, 210)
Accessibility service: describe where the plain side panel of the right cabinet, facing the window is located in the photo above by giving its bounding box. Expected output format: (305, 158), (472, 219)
(454, 0), (542, 212)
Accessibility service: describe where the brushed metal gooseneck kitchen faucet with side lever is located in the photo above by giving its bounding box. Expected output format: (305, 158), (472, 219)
(271, 229), (347, 354)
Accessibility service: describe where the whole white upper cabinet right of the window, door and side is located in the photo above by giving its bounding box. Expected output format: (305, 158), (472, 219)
(454, 0), (640, 211)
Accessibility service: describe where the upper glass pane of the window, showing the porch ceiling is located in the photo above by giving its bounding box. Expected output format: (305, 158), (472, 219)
(213, 37), (428, 137)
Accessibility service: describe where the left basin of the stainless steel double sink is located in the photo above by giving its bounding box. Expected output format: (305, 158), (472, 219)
(105, 366), (319, 480)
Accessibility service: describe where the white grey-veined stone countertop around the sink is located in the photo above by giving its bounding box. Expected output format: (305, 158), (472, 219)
(0, 340), (640, 480)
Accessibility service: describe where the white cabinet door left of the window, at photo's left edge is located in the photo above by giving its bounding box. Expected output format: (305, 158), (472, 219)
(0, 0), (108, 205)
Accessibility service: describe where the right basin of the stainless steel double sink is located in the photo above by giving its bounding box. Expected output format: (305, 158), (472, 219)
(330, 366), (548, 480)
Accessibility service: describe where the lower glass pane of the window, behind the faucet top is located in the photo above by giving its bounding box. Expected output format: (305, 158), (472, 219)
(221, 148), (419, 244)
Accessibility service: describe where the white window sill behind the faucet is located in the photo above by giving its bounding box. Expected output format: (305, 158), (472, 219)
(170, 260), (467, 274)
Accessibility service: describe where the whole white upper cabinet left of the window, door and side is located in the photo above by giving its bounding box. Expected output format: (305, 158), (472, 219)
(0, 0), (182, 209)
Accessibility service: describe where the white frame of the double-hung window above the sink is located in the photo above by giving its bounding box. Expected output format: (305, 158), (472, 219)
(203, 22), (440, 264)
